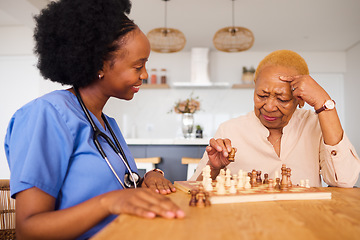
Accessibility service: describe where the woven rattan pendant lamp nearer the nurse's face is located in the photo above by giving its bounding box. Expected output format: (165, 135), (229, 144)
(147, 0), (186, 53)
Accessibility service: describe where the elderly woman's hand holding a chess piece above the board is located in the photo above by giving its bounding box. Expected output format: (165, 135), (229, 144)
(206, 138), (236, 170)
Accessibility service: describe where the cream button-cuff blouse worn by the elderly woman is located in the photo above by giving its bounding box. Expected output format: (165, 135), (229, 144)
(190, 109), (360, 187)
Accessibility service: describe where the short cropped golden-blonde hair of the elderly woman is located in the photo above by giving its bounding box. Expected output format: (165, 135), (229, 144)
(254, 50), (309, 82)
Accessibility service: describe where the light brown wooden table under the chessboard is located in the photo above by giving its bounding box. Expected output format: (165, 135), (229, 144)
(92, 188), (360, 240)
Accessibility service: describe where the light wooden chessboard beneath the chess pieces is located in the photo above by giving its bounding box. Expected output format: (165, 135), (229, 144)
(174, 181), (331, 204)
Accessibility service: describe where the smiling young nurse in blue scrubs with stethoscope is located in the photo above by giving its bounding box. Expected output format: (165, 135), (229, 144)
(5, 0), (184, 239)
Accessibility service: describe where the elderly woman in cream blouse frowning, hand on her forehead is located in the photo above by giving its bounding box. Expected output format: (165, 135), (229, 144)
(191, 50), (360, 187)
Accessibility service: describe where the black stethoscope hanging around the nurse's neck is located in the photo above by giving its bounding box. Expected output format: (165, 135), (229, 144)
(74, 87), (141, 189)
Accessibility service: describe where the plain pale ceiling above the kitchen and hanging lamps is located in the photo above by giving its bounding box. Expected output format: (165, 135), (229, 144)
(0, 0), (360, 52)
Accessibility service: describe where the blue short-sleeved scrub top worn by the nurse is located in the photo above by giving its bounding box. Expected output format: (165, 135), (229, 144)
(5, 90), (137, 239)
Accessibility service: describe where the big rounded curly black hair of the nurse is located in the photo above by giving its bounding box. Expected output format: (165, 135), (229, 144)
(34, 0), (138, 87)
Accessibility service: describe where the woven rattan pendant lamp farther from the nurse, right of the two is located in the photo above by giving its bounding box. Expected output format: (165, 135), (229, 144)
(213, 0), (254, 52)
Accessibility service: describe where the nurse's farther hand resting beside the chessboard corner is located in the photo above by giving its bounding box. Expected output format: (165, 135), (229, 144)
(141, 171), (176, 194)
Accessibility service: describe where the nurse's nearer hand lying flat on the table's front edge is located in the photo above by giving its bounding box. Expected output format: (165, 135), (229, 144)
(101, 188), (185, 218)
